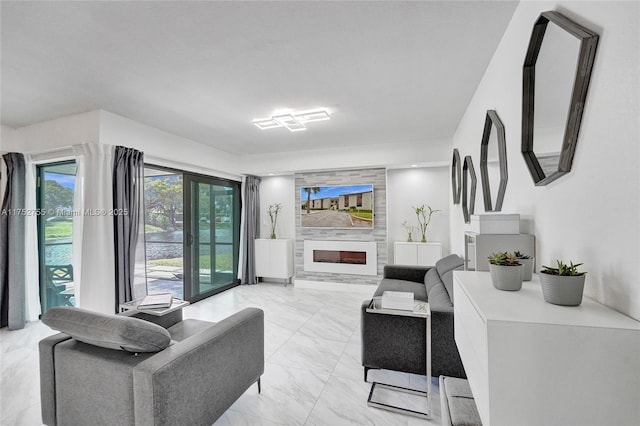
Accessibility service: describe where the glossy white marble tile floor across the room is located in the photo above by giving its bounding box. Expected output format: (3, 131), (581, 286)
(0, 282), (441, 426)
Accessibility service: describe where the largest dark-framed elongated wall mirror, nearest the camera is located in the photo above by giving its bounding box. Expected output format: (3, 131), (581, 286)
(522, 11), (598, 186)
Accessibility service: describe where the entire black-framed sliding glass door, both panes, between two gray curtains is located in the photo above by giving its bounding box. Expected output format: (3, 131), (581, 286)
(144, 166), (240, 302)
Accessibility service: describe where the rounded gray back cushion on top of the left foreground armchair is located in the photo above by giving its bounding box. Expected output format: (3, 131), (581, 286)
(42, 306), (171, 352)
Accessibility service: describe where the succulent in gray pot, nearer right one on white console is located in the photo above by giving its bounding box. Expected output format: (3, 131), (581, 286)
(540, 260), (586, 306)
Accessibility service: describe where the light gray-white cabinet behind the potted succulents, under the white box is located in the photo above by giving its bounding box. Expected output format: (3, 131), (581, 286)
(464, 232), (536, 271)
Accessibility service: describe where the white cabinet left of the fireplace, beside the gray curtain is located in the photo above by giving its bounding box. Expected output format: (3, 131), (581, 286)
(255, 238), (293, 282)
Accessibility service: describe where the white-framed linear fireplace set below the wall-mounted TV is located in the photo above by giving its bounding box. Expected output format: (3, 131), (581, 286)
(304, 240), (378, 275)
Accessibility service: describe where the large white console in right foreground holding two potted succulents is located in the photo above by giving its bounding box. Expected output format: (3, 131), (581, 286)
(454, 271), (640, 426)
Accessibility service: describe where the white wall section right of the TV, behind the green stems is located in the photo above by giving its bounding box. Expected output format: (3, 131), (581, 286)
(387, 167), (450, 263)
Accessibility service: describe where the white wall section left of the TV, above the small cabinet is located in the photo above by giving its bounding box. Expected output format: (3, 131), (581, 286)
(260, 175), (297, 239)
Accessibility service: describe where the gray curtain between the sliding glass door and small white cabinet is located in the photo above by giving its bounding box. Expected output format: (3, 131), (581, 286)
(242, 176), (260, 284)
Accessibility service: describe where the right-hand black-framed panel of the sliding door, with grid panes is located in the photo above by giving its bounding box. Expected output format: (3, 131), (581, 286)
(185, 174), (240, 301)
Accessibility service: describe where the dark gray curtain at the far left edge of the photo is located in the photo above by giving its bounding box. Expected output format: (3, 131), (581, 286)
(0, 152), (26, 330)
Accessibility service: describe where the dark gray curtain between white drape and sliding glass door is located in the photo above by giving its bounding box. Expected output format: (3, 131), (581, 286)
(113, 146), (146, 312)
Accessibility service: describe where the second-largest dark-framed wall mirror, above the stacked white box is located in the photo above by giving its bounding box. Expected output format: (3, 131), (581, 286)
(480, 110), (509, 212)
